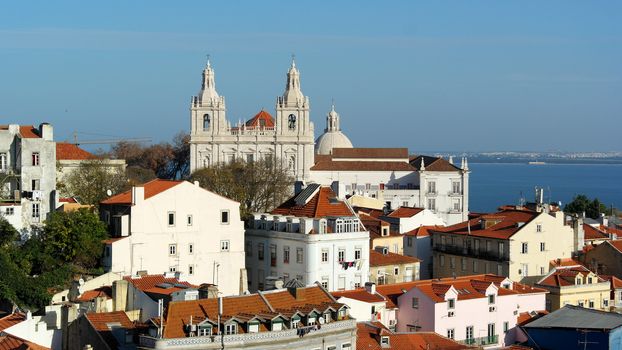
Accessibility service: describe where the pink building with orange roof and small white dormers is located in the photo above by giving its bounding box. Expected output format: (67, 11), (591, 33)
(376, 274), (547, 347)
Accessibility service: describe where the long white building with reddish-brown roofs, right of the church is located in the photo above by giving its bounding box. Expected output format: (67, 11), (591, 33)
(311, 148), (469, 225)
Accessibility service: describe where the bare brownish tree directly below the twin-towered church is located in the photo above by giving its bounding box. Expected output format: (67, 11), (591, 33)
(191, 158), (294, 218)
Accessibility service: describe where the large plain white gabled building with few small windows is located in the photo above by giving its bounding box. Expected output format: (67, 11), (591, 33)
(100, 179), (246, 295)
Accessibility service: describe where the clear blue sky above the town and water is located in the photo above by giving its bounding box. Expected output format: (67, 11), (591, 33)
(0, 0), (622, 153)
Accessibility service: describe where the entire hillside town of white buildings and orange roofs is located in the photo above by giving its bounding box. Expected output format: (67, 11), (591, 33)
(0, 59), (622, 350)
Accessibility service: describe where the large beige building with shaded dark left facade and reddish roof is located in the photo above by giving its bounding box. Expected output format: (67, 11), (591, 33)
(431, 207), (574, 282)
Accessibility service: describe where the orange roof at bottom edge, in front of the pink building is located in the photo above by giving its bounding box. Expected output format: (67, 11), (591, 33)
(356, 322), (472, 350)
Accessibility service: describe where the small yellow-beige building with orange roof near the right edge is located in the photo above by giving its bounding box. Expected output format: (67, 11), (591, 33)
(536, 264), (611, 311)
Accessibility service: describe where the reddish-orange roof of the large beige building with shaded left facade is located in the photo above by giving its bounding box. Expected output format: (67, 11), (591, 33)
(432, 210), (548, 239)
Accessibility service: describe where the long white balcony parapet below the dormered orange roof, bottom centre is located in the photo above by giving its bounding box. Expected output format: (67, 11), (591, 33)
(140, 319), (356, 349)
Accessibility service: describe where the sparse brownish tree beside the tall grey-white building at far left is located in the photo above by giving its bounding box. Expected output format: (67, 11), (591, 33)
(63, 159), (129, 206)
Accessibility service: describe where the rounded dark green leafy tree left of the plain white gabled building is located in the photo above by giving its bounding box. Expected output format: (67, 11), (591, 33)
(41, 208), (108, 269)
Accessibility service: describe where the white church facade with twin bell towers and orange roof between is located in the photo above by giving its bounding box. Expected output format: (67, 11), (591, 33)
(190, 61), (314, 180)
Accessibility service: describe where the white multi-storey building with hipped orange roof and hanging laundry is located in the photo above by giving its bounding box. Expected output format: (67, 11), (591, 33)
(246, 184), (369, 291)
